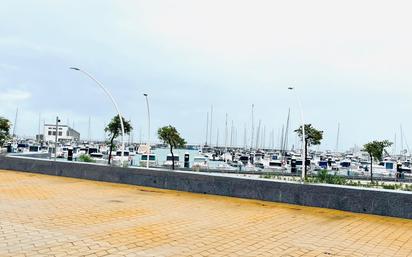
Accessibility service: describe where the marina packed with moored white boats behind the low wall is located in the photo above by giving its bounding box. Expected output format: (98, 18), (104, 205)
(7, 136), (412, 186)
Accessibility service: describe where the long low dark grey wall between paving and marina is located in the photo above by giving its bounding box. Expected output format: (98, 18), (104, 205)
(0, 156), (412, 219)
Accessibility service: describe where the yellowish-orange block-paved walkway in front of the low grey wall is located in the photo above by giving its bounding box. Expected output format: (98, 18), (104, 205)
(0, 170), (412, 257)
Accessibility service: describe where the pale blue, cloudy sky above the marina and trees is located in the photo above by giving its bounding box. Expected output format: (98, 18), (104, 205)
(0, 0), (412, 150)
